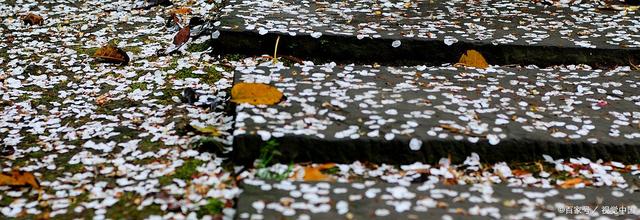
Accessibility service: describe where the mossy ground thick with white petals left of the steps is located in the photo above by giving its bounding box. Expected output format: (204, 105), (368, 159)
(0, 0), (241, 219)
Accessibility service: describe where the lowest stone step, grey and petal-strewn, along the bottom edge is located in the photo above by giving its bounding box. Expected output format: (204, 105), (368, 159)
(236, 180), (640, 219)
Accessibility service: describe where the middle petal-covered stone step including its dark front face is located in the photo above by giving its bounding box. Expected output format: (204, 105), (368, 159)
(232, 62), (640, 164)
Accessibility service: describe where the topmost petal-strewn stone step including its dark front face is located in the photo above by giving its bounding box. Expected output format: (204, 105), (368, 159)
(214, 0), (640, 67)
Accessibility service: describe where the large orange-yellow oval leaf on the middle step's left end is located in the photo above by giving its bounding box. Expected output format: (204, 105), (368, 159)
(231, 83), (282, 105)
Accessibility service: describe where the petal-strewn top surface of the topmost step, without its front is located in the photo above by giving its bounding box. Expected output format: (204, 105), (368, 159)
(221, 0), (640, 48)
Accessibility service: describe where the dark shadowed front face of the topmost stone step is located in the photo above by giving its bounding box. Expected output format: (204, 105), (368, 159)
(212, 30), (640, 69)
